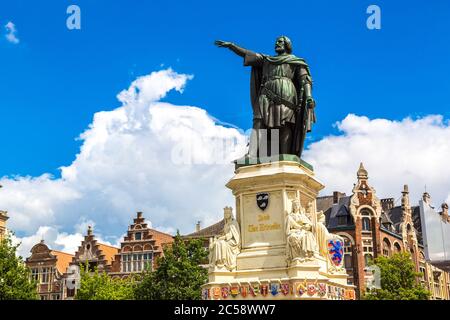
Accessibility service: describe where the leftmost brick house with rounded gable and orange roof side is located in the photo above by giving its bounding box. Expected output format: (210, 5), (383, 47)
(25, 240), (73, 300)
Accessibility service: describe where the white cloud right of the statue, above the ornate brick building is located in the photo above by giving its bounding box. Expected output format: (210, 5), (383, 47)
(305, 114), (450, 208)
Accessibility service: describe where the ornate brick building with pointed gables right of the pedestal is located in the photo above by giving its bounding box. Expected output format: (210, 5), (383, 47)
(317, 164), (450, 299)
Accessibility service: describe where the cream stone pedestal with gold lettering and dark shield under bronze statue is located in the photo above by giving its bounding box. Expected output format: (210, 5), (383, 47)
(203, 161), (354, 299)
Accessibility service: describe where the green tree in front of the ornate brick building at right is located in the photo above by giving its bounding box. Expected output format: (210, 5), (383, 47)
(364, 252), (430, 300)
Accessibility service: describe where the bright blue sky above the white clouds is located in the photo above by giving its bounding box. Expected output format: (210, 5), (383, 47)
(0, 0), (450, 175)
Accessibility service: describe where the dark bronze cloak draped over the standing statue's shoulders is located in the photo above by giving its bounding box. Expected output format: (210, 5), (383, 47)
(244, 52), (316, 157)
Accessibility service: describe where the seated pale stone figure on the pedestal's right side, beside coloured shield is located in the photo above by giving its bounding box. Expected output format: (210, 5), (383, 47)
(286, 199), (318, 264)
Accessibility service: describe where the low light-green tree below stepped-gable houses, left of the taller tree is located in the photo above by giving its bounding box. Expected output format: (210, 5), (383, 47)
(75, 265), (135, 300)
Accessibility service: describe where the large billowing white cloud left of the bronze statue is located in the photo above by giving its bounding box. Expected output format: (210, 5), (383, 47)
(0, 69), (246, 252)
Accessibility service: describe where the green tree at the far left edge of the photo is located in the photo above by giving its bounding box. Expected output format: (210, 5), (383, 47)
(0, 234), (39, 300)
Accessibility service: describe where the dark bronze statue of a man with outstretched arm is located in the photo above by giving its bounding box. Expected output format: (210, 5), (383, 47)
(215, 36), (316, 158)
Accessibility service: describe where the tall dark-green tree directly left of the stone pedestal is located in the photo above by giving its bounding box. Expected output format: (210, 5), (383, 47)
(135, 233), (208, 300)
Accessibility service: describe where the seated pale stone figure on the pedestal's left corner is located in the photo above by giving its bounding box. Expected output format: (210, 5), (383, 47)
(209, 207), (241, 271)
